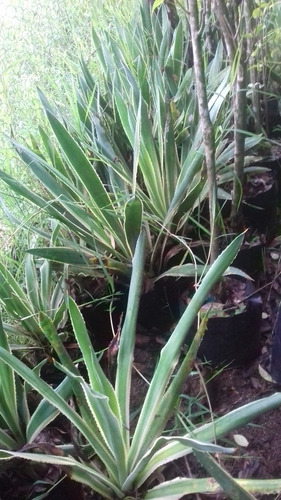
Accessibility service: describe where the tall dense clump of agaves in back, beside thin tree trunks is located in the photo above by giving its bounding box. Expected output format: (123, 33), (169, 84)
(0, 4), (260, 276)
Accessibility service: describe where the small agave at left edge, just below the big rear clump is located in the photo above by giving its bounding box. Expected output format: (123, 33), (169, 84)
(0, 225), (68, 349)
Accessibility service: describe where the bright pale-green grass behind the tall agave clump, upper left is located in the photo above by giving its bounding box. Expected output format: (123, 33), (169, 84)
(0, 0), (137, 260)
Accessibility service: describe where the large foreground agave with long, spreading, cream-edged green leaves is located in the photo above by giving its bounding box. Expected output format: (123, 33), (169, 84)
(0, 233), (281, 500)
